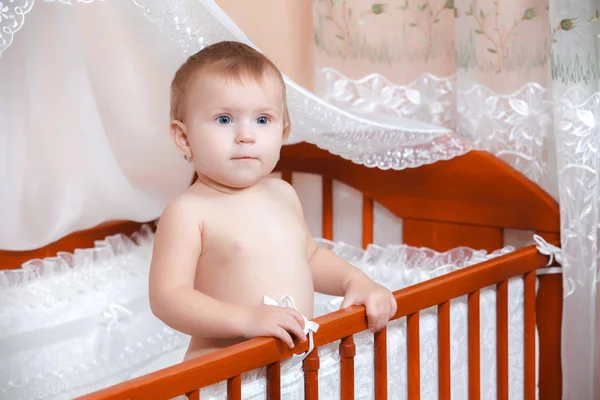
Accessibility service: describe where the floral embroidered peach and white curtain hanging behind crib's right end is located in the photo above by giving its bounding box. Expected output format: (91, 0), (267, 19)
(313, 0), (600, 399)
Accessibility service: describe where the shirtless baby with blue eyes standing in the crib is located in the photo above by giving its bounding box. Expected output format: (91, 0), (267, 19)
(150, 42), (396, 359)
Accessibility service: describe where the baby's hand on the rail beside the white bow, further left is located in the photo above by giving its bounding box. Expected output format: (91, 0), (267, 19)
(243, 304), (306, 348)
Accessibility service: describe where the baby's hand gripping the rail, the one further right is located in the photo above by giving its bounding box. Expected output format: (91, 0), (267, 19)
(340, 276), (397, 332)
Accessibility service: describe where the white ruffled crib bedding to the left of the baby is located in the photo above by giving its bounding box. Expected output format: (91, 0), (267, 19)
(0, 226), (189, 399)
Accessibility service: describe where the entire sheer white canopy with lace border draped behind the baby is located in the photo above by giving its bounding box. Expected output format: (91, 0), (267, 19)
(0, 0), (471, 250)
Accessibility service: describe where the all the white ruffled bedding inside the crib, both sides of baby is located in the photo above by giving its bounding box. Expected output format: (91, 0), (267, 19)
(0, 226), (513, 399)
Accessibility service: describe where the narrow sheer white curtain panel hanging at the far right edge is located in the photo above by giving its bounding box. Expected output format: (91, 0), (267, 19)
(549, 0), (600, 399)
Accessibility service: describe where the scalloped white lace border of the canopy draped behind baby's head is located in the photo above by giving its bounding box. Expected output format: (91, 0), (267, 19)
(0, 0), (469, 169)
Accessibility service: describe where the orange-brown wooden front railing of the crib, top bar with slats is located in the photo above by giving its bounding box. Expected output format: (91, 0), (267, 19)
(81, 242), (547, 400)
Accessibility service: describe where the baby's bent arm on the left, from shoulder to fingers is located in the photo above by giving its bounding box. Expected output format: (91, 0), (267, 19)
(149, 198), (306, 347)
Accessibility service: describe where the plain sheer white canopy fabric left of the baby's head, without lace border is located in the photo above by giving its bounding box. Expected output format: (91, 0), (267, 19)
(0, 1), (193, 250)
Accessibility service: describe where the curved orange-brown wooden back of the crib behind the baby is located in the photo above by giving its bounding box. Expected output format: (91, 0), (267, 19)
(0, 143), (560, 268)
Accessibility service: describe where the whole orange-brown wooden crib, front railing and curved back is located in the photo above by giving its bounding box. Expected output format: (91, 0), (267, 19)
(0, 143), (562, 400)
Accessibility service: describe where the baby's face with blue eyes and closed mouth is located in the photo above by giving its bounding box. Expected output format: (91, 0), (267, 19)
(186, 74), (284, 188)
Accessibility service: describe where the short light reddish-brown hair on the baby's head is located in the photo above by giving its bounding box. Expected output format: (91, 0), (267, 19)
(170, 41), (291, 138)
